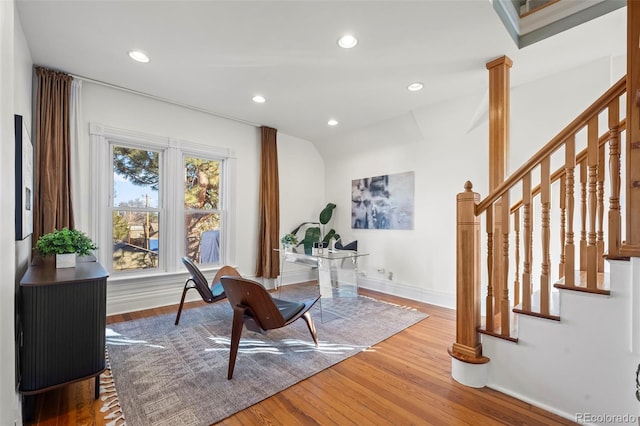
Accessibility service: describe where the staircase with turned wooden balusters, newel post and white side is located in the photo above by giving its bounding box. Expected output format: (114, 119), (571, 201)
(449, 71), (640, 424)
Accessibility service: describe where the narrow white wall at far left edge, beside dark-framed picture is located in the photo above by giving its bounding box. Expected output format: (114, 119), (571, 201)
(0, 1), (32, 425)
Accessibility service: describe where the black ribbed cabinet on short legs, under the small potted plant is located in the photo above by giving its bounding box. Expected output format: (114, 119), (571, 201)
(18, 257), (108, 419)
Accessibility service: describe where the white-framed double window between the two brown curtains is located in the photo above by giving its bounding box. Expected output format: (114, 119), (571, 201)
(91, 124), (232, 278)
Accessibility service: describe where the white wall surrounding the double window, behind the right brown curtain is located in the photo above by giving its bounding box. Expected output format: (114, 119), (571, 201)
(76, 81), (324, 314)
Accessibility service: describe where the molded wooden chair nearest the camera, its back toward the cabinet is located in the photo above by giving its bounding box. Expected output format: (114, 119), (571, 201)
(220, 276), (320, 380)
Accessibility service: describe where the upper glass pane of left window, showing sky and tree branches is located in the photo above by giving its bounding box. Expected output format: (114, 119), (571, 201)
(113, 146), (160, 208)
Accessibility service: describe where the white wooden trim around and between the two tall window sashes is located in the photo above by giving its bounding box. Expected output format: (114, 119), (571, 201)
(89, 123), (236, 286)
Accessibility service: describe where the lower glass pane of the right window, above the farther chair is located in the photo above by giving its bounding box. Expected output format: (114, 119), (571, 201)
(185, 212), (220, 263)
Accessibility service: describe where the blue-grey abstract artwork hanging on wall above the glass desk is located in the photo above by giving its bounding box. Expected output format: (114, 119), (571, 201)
(351, 172), (414, 229)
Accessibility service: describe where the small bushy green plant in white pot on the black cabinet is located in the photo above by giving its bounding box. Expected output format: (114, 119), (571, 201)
(36, 228), (98, 268)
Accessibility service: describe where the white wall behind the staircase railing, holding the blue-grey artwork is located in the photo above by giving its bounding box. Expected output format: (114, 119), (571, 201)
(321, 58), (624, 307)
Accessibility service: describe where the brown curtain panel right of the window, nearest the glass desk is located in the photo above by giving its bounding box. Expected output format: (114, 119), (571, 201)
(256, 127), (280, 278)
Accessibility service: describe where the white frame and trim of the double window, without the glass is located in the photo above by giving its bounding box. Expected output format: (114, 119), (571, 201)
(89, 123), (236, 283)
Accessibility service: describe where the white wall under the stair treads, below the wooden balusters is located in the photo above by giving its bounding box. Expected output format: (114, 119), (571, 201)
(482, 259), (640, 425)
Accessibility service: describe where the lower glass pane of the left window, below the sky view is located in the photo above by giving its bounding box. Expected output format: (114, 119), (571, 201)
(112, 210), (160, 271)
